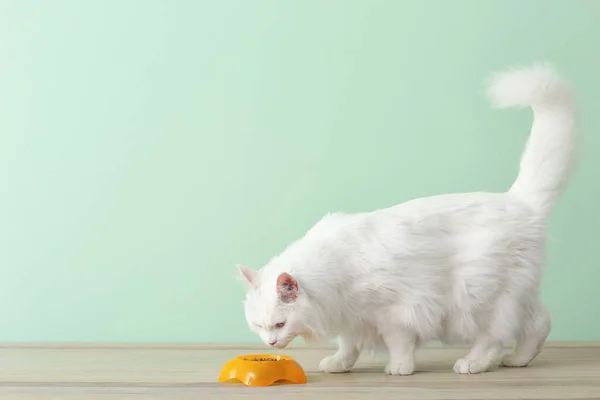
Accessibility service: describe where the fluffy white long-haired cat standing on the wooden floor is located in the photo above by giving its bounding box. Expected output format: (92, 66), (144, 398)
(238, 65), (577, 375)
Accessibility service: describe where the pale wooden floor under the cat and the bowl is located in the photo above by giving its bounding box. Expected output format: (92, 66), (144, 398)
(0, 344), (600, 400)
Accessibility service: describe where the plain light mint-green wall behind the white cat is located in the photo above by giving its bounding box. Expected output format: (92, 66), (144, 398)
(0, 0), (600, 341)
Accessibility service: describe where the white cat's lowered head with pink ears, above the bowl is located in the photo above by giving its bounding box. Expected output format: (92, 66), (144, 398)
(238, 266), (311, 349)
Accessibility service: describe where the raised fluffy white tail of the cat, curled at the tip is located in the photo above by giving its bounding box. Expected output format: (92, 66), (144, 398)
(488, 64), (577, 215)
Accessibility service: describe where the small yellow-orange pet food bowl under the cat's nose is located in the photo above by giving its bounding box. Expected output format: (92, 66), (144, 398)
(219, 354), (306, 386)
